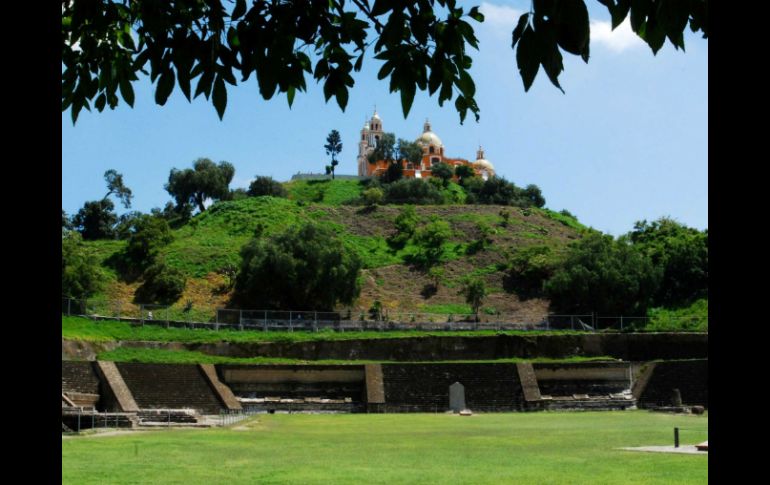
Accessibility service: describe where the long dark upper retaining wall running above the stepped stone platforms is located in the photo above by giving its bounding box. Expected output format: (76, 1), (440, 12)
(62, 333), (708, 362)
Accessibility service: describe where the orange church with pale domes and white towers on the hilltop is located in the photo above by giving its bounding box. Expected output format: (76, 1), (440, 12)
(358, 109), (495, 180)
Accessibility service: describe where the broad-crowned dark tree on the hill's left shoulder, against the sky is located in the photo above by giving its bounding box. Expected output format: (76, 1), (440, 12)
(165, 158), (235, 212)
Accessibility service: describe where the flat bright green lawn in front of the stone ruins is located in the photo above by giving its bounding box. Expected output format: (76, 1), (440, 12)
(62, 411), (708, 485)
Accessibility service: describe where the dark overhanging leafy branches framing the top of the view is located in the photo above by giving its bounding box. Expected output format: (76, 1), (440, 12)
(61, 0), (708, 123)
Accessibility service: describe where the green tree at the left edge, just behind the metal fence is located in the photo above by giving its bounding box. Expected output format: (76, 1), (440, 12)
(61, 231), (105, 298)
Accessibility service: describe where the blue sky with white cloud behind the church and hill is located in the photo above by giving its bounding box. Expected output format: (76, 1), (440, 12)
(62, 2), (708, 236)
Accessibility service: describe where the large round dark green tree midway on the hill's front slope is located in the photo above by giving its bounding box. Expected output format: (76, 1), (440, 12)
(234, 223), (361, 310)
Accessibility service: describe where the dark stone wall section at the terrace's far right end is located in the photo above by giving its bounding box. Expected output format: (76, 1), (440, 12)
(638, 359), (708, 408)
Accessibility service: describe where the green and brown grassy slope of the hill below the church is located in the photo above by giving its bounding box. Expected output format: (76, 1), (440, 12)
(88, 180), (587, 314)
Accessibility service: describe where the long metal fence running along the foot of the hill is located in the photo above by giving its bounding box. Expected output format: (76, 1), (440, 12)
(62, 298), (702, 332)
